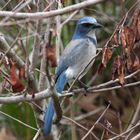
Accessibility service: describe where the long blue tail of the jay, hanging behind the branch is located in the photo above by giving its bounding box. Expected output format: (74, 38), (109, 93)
(44, 72), (68, 136)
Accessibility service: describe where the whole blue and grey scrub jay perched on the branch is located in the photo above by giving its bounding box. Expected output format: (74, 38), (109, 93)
(44, 17), (102, 136)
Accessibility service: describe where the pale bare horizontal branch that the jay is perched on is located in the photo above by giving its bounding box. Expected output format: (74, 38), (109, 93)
(0, 81), (140, 104)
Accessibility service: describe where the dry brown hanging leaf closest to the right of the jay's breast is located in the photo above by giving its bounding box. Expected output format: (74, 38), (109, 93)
(102, 47), (112, 67)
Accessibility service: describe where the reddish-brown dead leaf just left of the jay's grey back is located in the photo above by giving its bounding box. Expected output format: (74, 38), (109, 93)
(46, 47), (57, 67)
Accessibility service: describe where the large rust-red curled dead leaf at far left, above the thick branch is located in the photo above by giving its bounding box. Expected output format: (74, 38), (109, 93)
(10, 60), (25, 92)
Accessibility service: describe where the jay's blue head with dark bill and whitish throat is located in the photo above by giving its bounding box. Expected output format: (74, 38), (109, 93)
(73, 17), (103, 39)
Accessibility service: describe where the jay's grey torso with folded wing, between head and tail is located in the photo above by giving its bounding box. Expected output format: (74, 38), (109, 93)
(56, 38), (96, 79)
